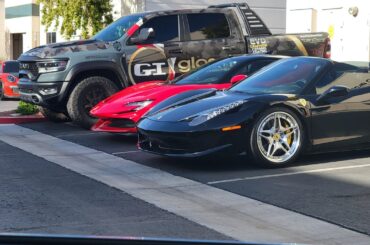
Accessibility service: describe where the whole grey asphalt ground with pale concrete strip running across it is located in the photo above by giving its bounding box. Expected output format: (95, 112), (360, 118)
(0, 117), (370, 244)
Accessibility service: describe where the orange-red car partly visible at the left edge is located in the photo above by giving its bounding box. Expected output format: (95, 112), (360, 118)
(0, 60), (19, 100)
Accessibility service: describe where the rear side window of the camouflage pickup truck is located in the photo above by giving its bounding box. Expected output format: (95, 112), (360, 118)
(187, 13), (230, 41)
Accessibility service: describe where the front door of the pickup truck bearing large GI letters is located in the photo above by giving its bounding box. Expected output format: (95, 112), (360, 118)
(125, 14), (185, 84)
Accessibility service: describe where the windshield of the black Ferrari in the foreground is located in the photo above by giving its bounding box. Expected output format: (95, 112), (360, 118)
(230, 58), (329, 94)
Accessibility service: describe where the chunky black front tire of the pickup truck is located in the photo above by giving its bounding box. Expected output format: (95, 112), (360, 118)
(67, 76), (118, 129)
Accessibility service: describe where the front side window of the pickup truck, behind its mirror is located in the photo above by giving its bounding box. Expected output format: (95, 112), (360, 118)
(134, 15), (180, 44)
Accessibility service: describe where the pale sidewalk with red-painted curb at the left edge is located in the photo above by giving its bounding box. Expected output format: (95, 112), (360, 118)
(0, 100), (46, 124)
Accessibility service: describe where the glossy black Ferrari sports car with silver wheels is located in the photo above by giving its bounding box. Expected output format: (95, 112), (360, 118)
(138, 57), (370, 166)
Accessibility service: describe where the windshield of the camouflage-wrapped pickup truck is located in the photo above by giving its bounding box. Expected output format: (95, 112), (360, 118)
(93, 14), (144, 42)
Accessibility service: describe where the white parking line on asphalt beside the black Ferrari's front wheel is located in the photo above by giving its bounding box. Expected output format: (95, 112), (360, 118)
(207, 163), (370, 185)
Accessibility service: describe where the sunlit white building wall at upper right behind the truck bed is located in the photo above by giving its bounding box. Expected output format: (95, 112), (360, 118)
(286, 0), (370, 66)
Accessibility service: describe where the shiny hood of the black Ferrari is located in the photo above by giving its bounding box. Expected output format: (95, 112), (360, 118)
(148, 91), (253, 122)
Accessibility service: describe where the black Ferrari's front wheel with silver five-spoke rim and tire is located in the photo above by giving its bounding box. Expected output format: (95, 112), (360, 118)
(248, 107), (305, 167)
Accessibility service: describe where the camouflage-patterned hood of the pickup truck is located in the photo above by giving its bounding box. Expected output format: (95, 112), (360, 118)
(20, 39), (111, 60)
